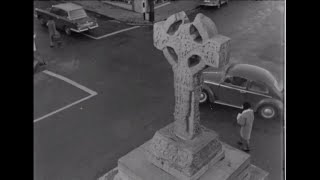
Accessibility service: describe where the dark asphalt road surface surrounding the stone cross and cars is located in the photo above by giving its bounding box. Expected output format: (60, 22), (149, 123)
(34, 1), (284, 180)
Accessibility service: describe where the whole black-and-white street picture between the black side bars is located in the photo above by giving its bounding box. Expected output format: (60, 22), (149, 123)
(30, 0), (286, 180)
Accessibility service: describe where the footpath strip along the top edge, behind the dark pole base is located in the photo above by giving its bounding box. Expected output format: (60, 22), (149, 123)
(72, 0), (198, 25)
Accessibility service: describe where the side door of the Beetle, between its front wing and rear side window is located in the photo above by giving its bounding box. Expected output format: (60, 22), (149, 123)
(217, 76), (248, 108)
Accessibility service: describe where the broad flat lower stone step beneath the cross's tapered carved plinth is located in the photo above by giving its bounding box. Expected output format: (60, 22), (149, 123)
(114, 141), (268, 180)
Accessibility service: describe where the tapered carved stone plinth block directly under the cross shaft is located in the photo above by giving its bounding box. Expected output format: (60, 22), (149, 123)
(145, 123), (224, 180)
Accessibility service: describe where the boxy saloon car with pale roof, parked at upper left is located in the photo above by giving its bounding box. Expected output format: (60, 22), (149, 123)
(35, 3), (98, 35)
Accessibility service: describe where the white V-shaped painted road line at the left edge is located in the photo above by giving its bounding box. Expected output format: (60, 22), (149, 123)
(33, 70), (98, 123)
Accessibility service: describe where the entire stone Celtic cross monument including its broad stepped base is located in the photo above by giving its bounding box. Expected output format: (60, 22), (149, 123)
(112, 12), (267, 180)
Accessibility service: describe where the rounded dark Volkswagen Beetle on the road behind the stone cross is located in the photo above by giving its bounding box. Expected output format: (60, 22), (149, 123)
(200, 64), (283, 119)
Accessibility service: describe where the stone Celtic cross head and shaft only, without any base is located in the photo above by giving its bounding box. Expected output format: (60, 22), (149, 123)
(153, 12), (230, 140)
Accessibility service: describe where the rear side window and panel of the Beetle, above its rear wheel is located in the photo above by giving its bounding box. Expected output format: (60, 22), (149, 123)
(246, 81), (272, 106)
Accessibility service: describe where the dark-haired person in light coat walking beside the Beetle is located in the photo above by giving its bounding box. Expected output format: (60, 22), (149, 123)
(237, 103), (254, 152)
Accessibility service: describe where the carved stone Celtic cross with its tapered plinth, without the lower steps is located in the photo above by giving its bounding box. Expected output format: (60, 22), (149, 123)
(136, 12), (230, 180)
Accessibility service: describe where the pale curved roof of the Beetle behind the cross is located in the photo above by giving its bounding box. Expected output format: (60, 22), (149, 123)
(226, 64), (278, 90)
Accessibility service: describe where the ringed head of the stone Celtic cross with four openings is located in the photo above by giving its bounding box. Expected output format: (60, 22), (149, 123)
(153, 11), (230, 74)
